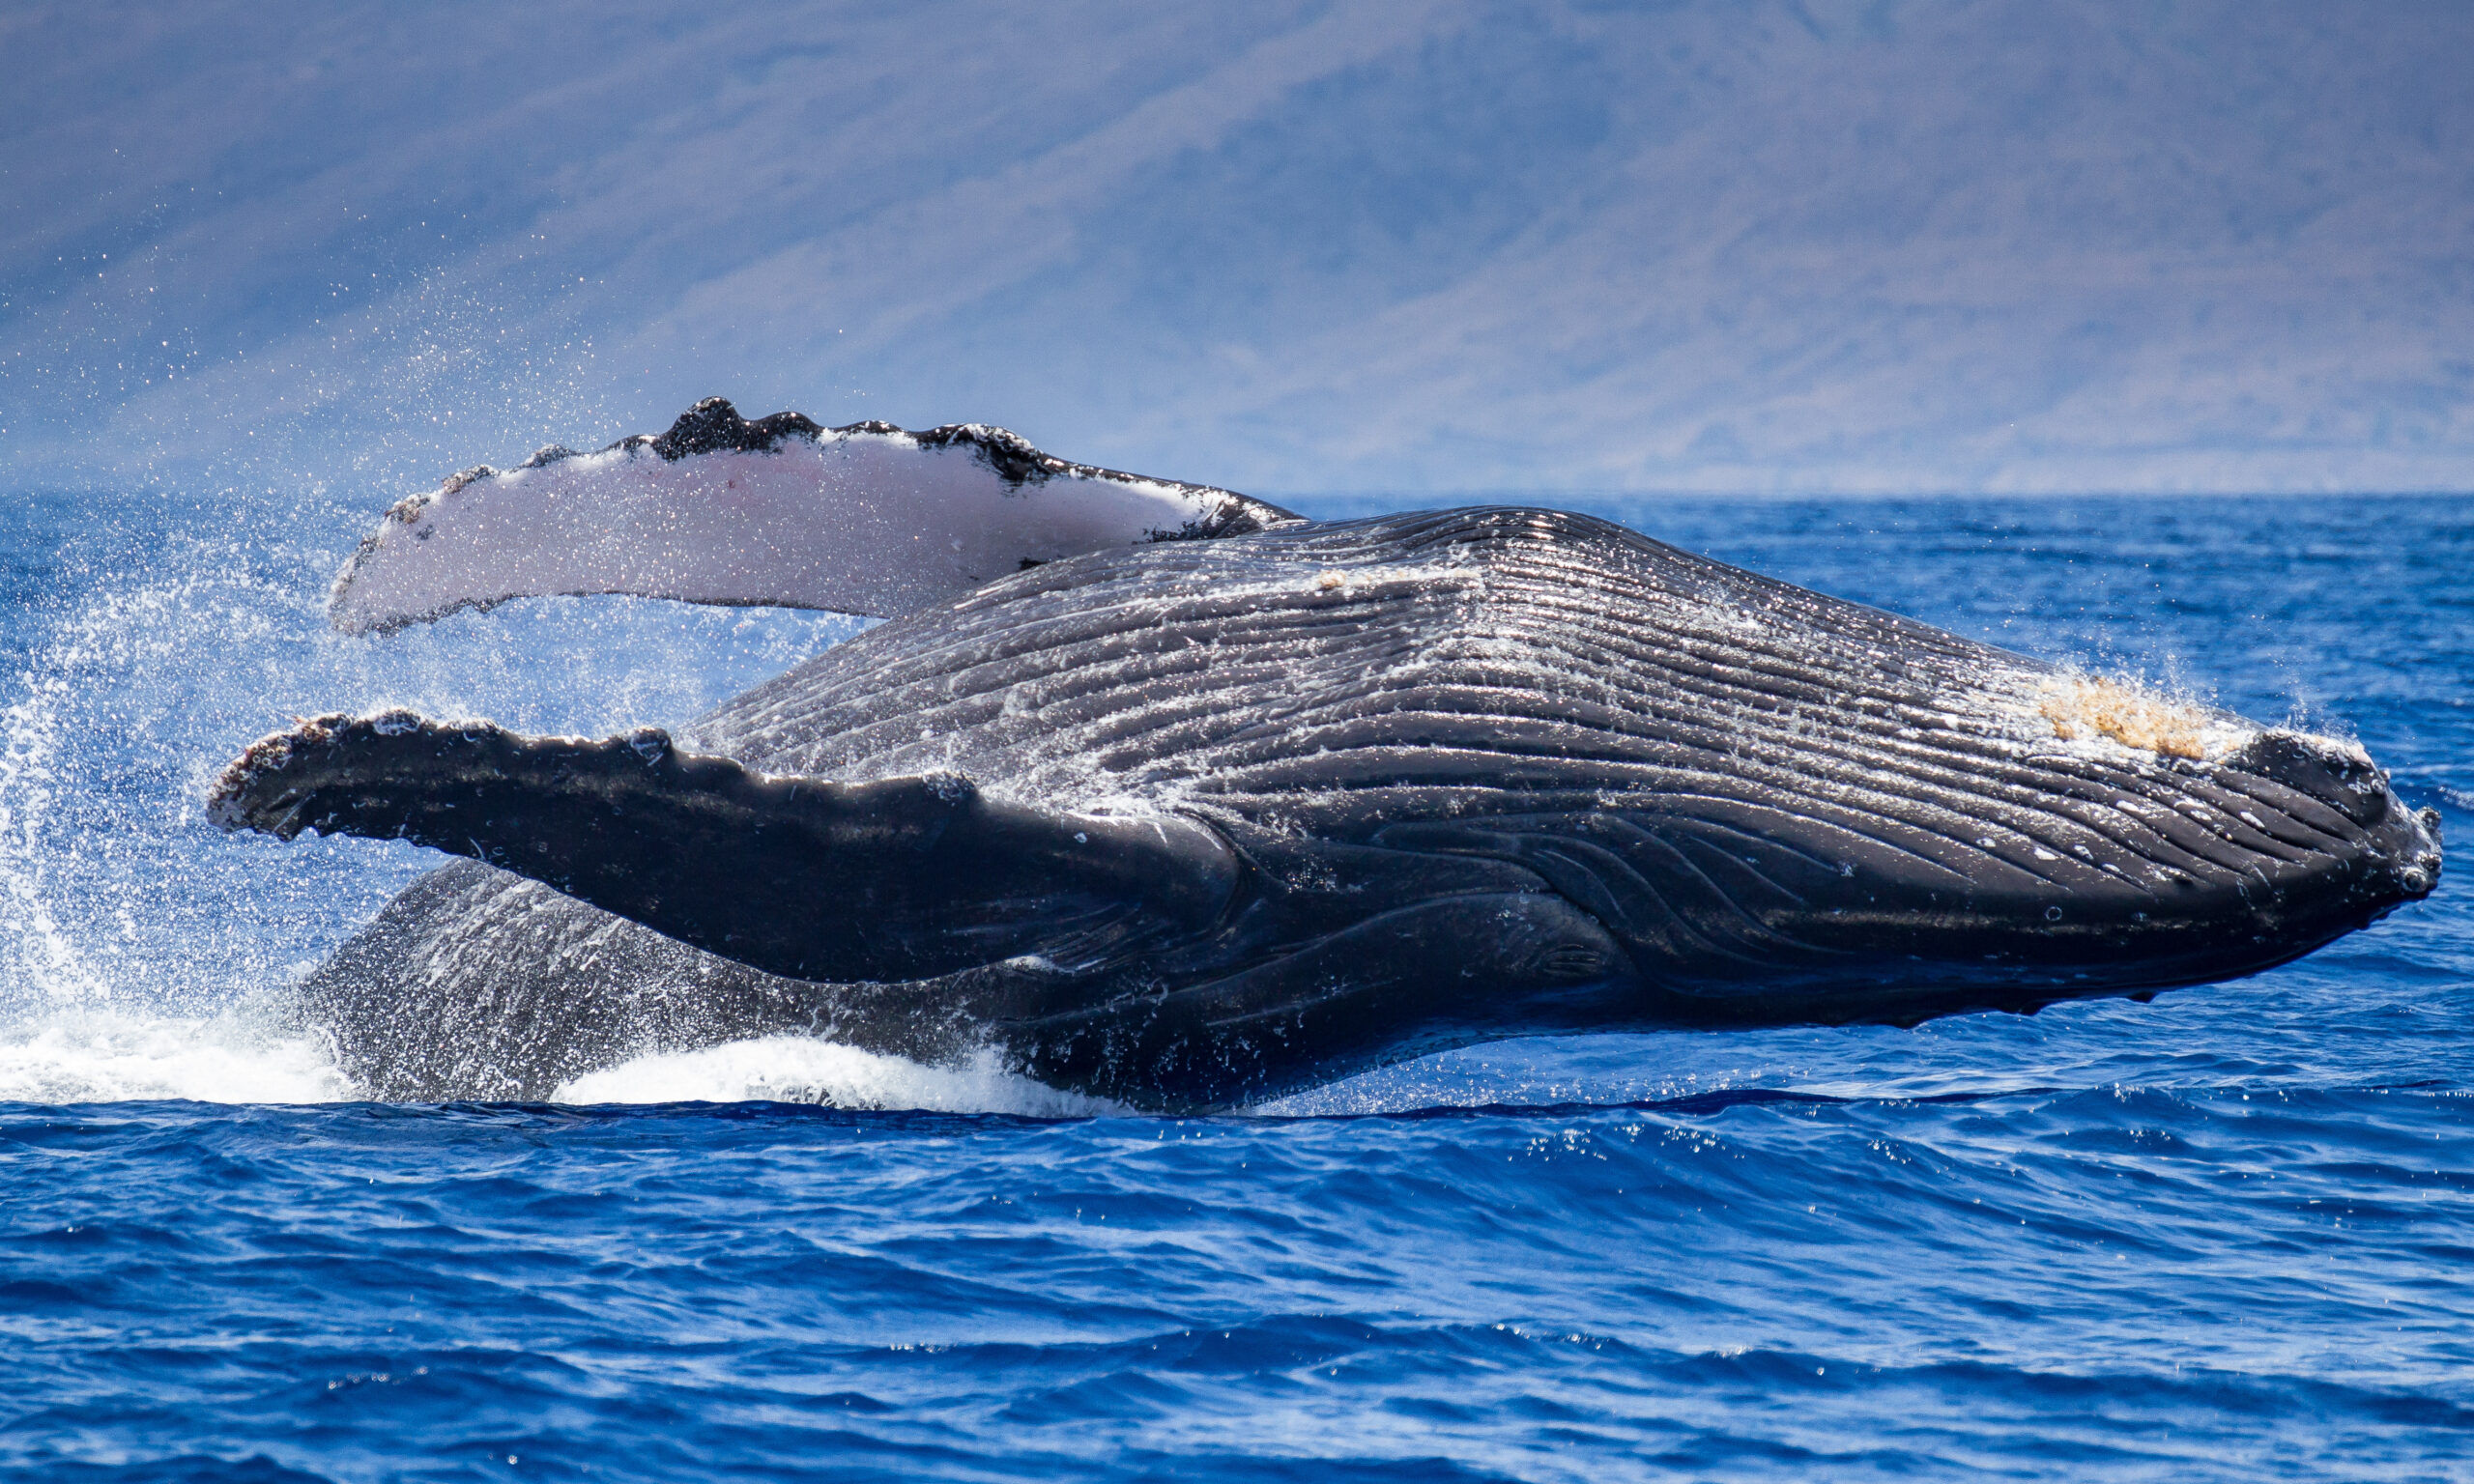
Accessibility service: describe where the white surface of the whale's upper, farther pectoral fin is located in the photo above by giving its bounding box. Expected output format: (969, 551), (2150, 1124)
(329, 430), (1237, 633)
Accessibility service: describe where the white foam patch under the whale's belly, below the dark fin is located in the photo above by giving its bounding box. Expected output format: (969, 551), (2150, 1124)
(549, 1037), (1121, 1118)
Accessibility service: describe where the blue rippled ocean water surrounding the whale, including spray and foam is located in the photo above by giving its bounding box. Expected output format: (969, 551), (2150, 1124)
(0, 492), (2474, 1481)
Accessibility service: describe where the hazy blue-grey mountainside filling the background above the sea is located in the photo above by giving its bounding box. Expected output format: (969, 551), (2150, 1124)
(0, 0), (2474, 498)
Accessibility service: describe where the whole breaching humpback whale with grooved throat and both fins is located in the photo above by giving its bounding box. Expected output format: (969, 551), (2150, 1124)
(208, 401), (2439, 1110)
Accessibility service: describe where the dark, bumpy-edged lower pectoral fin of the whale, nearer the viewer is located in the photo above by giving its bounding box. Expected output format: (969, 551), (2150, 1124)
(208, 712), (1242, 982)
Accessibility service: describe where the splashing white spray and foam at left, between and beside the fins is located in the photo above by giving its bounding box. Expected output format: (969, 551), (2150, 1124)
(0, 492), (856, 1100)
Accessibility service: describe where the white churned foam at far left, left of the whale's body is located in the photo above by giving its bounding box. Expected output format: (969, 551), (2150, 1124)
(0, 1007), (357, 1103)
